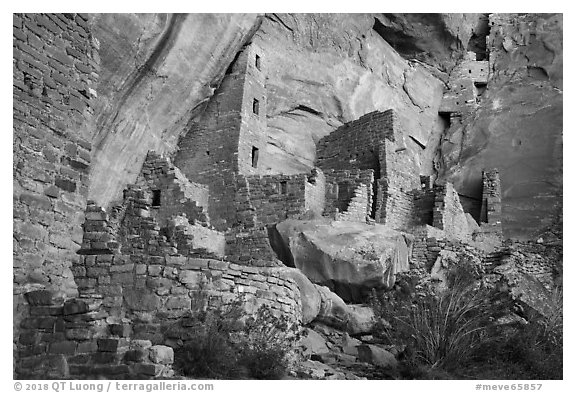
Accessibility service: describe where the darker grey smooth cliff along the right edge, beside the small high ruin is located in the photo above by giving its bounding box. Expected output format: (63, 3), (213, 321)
(437, 14), (563, 238)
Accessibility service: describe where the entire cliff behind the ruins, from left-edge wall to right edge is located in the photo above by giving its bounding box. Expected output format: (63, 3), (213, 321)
(67, 14), (562, 237)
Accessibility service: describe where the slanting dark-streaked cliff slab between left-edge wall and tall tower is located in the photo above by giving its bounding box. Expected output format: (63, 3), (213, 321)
(89, 14), (259, 205)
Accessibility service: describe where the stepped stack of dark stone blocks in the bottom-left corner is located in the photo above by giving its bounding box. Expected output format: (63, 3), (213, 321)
(16, 290), (174, 379)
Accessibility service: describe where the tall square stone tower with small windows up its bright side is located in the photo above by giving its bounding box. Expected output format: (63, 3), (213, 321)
(174, 44), (266, 231)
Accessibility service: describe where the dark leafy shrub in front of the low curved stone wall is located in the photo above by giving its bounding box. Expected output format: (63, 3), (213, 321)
(175, 299), (299, 379)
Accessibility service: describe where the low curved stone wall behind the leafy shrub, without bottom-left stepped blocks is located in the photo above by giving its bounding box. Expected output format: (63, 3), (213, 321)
(73, 255), (301, 344)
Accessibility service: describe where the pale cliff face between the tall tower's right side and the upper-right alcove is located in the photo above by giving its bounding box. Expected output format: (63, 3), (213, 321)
(254, 14), (443, 173)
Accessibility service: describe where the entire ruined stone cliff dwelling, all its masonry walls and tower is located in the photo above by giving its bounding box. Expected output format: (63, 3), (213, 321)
(14, 14), (556, 379)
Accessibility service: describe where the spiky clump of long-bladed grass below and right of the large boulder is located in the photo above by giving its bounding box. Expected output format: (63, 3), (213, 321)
(372, 265), (505, 377)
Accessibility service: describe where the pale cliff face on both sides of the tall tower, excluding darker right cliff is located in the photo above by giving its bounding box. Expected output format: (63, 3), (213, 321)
(89, 14), (475, 205)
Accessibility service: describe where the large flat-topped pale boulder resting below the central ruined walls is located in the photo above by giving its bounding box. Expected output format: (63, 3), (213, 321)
(276, 220), (410, 302)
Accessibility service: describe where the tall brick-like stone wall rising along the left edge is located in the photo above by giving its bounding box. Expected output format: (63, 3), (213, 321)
(12, 14), (100, 374)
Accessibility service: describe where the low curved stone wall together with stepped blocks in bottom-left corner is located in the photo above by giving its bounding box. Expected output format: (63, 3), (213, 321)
(16, 254), (301, 379)
